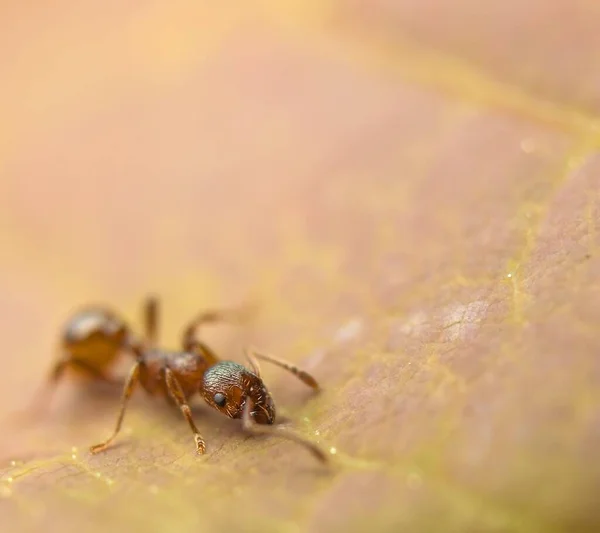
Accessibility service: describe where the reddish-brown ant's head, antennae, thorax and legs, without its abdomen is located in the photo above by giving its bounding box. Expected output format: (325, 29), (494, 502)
(90, 298), (327, 462)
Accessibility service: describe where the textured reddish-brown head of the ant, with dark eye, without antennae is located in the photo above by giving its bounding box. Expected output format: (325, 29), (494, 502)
(201, 361), (275, 424)
